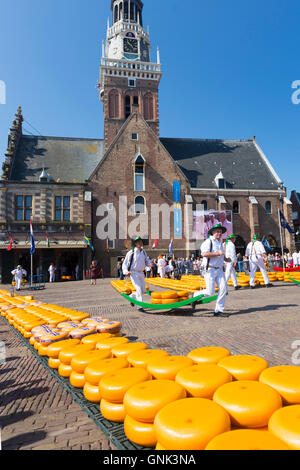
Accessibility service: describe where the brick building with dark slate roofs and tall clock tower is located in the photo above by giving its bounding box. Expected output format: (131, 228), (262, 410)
(0, 0), (294, 280)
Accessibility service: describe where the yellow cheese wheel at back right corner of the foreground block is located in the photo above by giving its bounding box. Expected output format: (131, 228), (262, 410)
(218, 355), (268, 380)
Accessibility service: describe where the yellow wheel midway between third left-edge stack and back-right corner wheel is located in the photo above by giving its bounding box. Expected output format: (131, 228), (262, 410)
(147, 356), (193, 380)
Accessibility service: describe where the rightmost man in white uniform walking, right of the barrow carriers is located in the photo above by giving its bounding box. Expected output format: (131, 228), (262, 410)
(246, 235), (273, 289)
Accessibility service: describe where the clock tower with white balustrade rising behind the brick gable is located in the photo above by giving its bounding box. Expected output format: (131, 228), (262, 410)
(98, 0), (162, 149)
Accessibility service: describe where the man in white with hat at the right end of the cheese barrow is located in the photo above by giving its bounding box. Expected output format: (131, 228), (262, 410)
(194, 224), (231, 317)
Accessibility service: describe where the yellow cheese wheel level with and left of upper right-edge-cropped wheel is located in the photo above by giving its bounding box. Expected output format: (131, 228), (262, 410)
(175, 364), (232, 399)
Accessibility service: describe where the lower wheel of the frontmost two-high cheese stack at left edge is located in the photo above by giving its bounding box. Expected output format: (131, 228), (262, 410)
(124, 415), (157, 447)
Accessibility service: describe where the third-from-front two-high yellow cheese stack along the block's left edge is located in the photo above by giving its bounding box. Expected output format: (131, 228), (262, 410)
(83, 358), (128, 403)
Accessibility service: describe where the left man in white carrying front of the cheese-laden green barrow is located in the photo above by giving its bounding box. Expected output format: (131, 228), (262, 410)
(122, 237), (150, 312)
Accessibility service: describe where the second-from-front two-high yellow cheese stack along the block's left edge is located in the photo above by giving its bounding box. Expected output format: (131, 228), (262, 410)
(99, 367), (151, 423)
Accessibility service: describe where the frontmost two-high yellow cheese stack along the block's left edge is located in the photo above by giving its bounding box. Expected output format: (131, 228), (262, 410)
(124, 380), (186, 447)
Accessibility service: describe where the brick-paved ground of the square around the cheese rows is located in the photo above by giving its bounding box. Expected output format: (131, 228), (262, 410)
(0, 280), (300, 450)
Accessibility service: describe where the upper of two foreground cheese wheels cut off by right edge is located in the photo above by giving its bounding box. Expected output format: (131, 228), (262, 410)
(259, 366), (300, 405)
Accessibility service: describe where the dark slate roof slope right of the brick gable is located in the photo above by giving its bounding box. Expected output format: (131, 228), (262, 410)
(160, 138), (282, 190)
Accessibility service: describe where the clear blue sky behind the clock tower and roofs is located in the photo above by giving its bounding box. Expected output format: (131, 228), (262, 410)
(0, 0), (300, 194)
